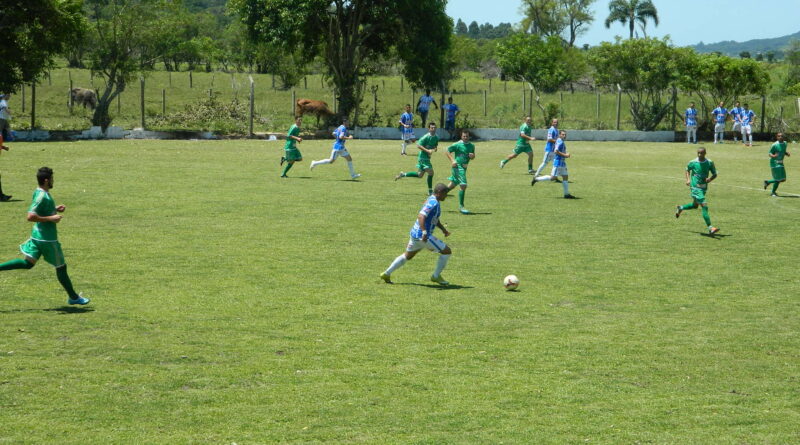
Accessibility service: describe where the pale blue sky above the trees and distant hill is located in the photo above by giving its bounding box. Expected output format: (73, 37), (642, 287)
(447, 0), (800, 46)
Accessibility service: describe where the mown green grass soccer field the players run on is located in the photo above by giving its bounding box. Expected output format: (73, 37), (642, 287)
(0, 140), (800, 444)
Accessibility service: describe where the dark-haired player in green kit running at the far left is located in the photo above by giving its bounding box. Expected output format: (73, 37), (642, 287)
(0, 167), (89, 304)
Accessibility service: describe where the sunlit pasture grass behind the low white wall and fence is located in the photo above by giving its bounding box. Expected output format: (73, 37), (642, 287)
(9, 68), (798, 134)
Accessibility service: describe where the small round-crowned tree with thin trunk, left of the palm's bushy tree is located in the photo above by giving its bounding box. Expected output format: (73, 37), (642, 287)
(497, 33), (585, 124)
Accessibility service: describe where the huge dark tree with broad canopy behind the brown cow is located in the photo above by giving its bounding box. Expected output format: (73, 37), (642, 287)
(234, 0), (453, 121)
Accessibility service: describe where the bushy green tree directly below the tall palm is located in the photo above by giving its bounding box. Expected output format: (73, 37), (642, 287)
(589, 38), (686, 131)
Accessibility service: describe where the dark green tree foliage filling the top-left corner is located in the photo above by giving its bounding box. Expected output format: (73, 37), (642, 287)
(0, 0), (85, 92)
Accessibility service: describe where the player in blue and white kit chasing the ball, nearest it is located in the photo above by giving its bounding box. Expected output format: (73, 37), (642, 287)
(381, 183), (453, 286)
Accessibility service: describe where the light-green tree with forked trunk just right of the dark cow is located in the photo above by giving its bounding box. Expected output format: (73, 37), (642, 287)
(86, 0), (158, 129)
